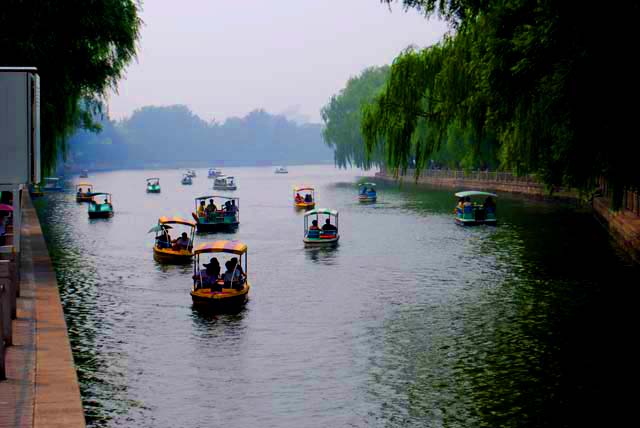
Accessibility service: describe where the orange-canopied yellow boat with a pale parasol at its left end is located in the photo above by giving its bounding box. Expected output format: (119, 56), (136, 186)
(149, 217), (196, 264)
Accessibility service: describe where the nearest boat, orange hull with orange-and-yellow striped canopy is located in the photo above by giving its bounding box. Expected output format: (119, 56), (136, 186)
(191, 241), (251, 308)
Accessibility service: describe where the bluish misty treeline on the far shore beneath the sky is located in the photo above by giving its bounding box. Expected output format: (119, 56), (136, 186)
(66, 105), (333, 170)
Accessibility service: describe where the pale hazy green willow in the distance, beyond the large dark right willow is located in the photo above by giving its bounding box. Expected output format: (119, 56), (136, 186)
(321, 66), (389, 169)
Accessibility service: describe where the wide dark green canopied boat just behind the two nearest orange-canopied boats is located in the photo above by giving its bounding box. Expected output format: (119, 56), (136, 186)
(192, 195), (240, 233)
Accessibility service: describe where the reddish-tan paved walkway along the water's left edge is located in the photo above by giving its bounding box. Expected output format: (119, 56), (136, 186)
(0, 192), (85, 428)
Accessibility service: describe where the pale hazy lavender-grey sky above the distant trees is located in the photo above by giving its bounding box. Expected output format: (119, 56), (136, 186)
(109, 0), (446, 122)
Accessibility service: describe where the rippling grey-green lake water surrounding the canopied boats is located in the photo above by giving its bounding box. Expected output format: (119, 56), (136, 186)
(36, 166), (640, 428)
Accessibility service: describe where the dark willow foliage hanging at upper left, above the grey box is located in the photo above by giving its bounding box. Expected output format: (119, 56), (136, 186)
(0, 0), (141, 174)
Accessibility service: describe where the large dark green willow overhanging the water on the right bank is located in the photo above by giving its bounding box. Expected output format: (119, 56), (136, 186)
(362, 0), (640, 204)
